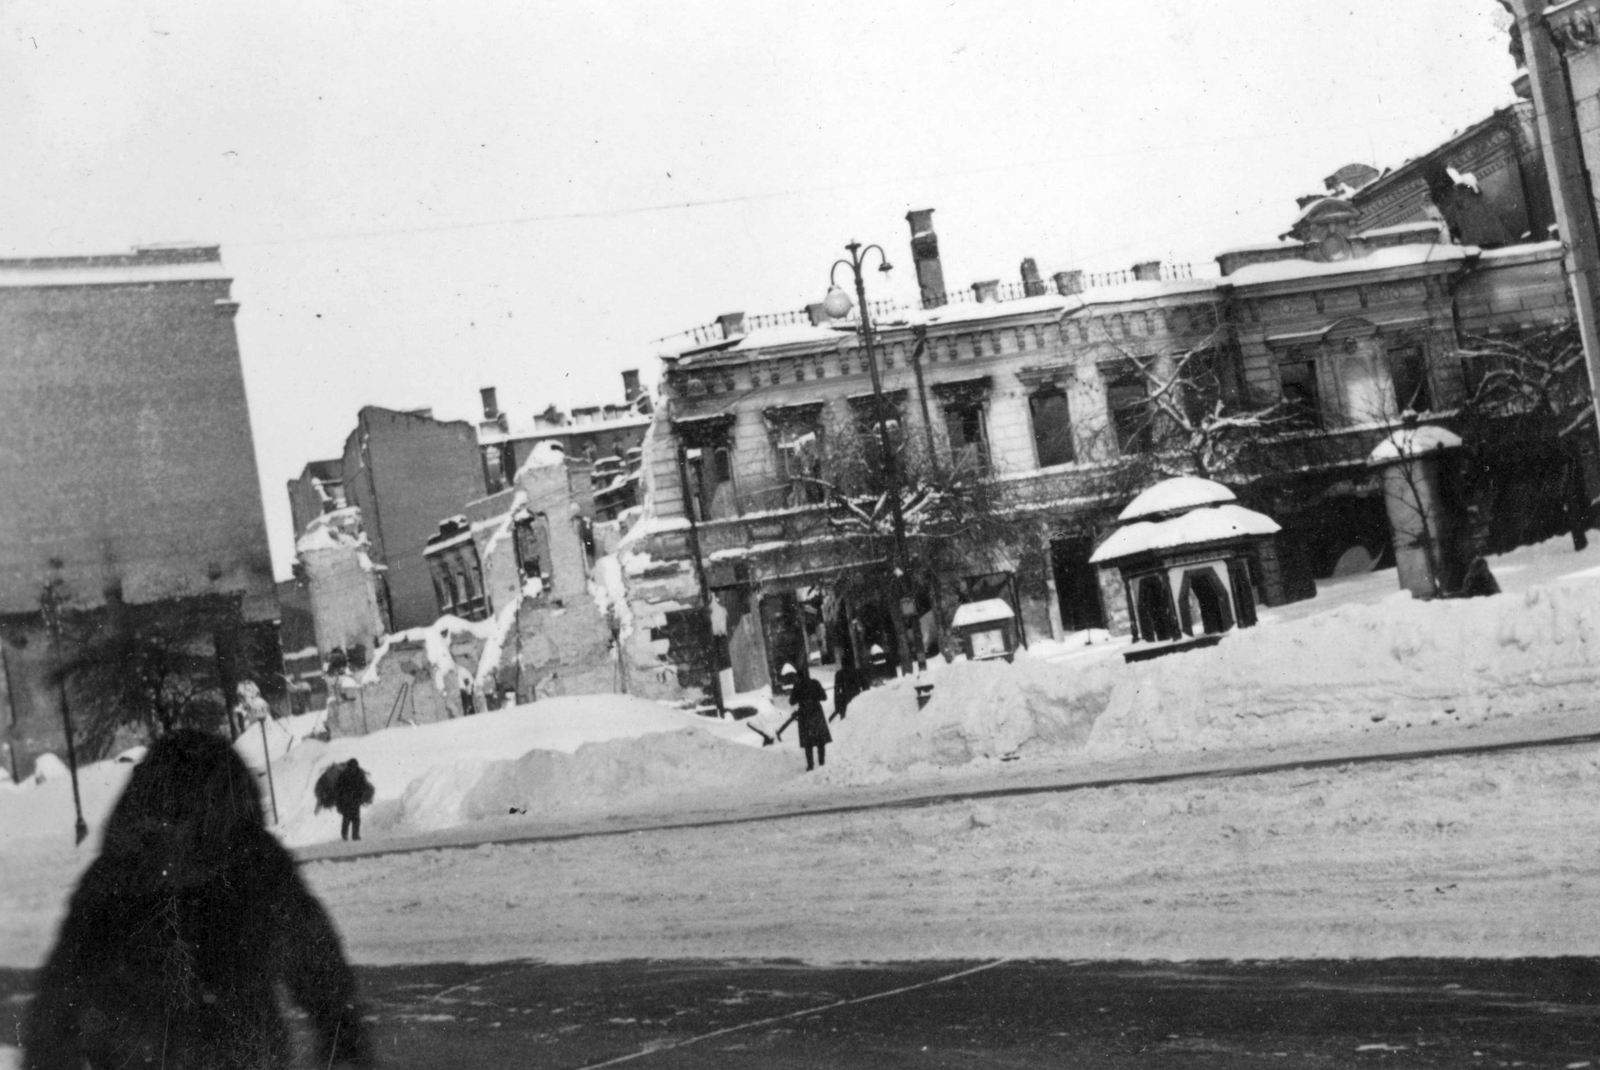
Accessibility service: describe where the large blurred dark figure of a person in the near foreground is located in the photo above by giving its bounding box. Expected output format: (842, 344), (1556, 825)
(22, 729), (373, 1070)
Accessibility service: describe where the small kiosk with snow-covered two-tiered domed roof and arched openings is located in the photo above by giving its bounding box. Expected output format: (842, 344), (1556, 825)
(1090, 475), (1285, 661)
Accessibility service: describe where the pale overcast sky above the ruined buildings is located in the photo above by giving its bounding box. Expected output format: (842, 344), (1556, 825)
(0, 0), (1515, 576)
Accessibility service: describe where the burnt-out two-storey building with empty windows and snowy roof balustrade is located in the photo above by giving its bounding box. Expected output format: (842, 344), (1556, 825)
(629, 197), (1568, 693)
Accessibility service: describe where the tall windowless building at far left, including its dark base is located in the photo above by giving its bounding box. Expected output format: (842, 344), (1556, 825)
(0, 246), (282, 773)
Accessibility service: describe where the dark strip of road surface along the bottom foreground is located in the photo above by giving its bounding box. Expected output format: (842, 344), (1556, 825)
(0, 958), (1600, 1070)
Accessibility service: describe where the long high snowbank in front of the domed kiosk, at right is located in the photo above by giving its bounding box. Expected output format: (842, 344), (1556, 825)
(1090, 581), (1600, 757)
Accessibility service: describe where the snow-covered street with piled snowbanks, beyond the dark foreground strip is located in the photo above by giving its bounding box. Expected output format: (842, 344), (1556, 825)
(0, 541), (1600, 968)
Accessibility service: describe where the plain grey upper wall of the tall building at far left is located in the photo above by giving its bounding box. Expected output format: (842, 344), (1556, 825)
(0, 250), (277, 619)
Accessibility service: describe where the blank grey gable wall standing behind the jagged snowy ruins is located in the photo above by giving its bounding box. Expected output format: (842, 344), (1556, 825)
(344, 406), (486, 632)
